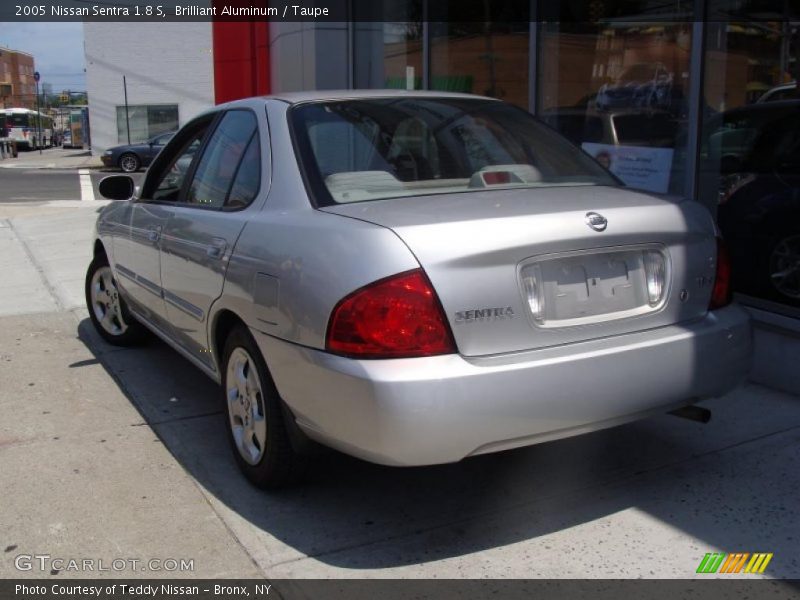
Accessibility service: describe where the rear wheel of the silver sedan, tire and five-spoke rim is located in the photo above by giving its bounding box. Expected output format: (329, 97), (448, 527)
(222, 326), (304, 489)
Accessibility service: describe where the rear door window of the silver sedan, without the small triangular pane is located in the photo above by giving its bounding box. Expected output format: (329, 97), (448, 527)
(185, 110), (258, 208)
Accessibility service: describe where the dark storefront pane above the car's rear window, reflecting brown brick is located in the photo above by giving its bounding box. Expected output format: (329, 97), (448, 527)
(430, 0), (530, 110)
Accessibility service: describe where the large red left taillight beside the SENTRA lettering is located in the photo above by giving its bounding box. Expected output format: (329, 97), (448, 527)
(326, 269), (456, 358)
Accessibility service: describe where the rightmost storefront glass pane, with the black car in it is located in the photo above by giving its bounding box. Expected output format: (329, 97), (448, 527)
(698, 0), (800, 314)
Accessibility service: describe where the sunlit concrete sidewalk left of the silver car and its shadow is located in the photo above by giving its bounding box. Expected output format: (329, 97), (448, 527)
(0, 208), (260, 578)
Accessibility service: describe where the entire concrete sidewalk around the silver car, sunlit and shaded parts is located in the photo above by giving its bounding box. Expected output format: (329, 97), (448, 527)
(0, 207), (800, 578)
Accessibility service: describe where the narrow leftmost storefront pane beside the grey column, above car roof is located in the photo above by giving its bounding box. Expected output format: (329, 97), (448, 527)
(353, 0), (423, 90)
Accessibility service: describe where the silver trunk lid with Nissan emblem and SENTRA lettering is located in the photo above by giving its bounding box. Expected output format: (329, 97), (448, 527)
(322, 186), (716, 356)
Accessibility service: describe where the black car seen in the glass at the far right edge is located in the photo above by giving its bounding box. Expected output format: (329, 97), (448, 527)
(702, 100), (800, 306)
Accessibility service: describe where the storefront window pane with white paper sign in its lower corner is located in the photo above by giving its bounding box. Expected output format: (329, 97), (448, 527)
(538, 1), (692, 194)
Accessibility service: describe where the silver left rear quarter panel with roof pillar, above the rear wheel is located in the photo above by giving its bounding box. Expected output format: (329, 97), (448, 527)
(209, 100), (419, 348)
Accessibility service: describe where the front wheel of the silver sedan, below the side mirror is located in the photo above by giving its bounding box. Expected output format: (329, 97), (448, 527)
(85, 255), (145, 346)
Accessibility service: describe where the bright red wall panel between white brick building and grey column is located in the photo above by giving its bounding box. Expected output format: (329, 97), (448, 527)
(211, 21), (270, 104)
